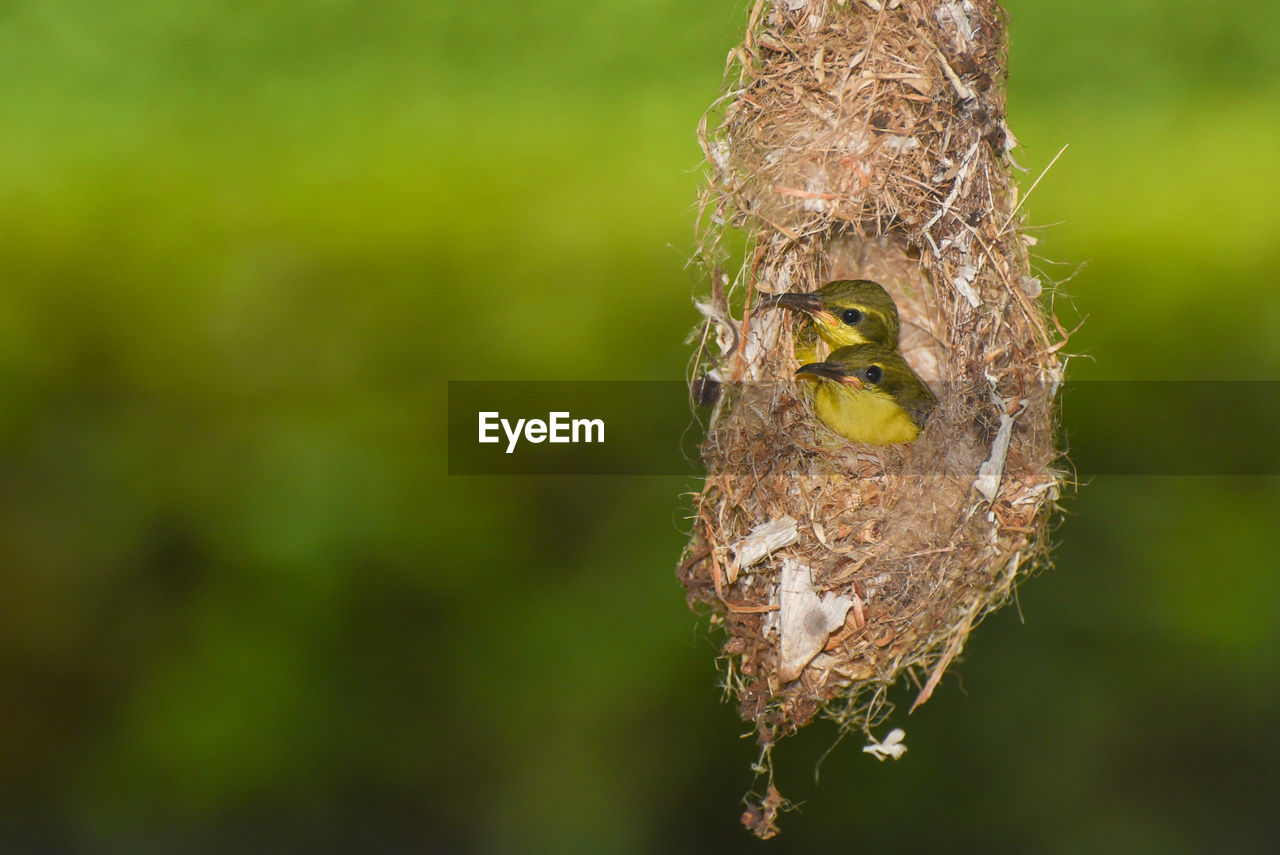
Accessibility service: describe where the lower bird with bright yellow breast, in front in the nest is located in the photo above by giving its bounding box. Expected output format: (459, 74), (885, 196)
(796, 344), (938, 445)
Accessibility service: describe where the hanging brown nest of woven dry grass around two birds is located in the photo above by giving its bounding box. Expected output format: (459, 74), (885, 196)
(678, 0), (1065, 837)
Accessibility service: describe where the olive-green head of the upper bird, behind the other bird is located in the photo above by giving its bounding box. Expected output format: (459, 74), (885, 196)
(768, 279), (899, 347)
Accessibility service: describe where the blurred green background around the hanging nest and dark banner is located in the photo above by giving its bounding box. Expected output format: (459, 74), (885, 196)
(0, 0), (1280, 852)
